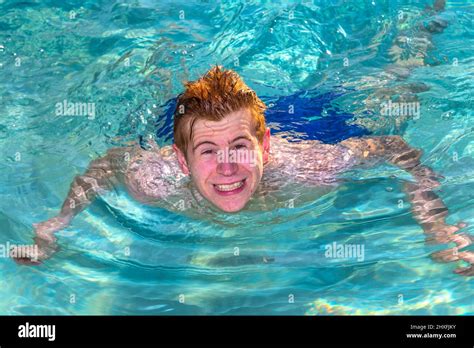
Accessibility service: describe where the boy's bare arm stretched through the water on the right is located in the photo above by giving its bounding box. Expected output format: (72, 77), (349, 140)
(341, 136), (474, 275)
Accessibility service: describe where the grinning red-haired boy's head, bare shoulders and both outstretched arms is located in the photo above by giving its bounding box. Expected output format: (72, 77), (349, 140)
(17, 66), (474, 275)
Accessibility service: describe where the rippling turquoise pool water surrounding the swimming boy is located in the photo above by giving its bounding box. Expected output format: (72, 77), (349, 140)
(0, 1), (474, 315)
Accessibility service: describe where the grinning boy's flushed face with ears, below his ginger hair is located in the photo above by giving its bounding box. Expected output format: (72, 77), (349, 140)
(173, 109), (270, 212)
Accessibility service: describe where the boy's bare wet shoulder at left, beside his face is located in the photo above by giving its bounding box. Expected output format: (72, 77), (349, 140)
(124, 146), (186, 202)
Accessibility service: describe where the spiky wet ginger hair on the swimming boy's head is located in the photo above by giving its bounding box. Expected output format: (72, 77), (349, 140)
(174, 65), (266, 154)
